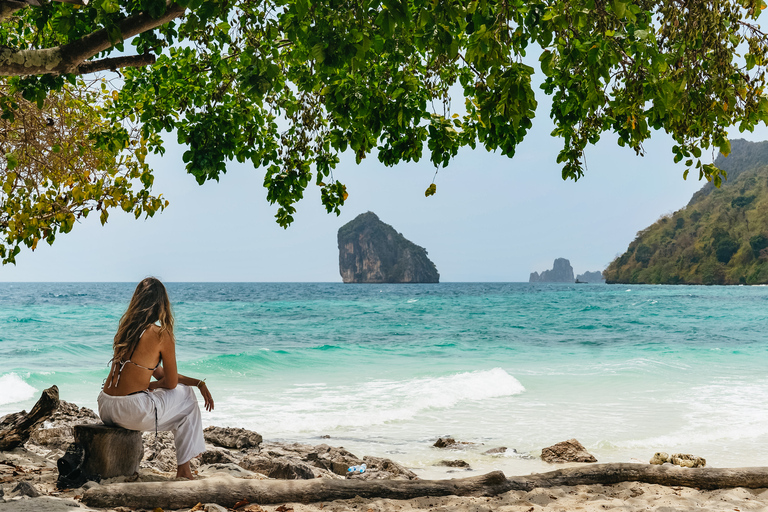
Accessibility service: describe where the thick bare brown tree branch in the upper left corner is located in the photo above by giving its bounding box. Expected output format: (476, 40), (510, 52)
(0, 0), (186, 76)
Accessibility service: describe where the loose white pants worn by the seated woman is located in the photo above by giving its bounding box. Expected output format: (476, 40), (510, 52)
(97, 384), (205, 466)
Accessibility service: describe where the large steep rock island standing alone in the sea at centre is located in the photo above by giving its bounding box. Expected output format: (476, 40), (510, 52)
(338, 212), (440, 283)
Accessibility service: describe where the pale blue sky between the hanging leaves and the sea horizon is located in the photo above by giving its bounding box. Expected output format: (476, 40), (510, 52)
(0, 70), (768, 282)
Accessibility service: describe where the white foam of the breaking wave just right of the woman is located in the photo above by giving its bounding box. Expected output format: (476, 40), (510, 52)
(217, 368), (525, 434)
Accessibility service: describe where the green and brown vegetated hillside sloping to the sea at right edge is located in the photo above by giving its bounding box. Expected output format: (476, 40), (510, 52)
(603, 140), (768, 284)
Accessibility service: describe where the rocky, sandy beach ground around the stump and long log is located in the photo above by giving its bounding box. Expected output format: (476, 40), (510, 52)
(0, 401), (768, 512)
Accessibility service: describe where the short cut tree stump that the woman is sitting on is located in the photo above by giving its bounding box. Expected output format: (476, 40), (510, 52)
(56, 424), (144, 489)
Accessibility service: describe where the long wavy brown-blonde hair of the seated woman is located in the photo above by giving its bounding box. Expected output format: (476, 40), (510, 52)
(112, 277), (173, 361)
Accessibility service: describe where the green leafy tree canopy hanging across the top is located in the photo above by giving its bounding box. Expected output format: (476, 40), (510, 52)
(0, 0), (768, 261)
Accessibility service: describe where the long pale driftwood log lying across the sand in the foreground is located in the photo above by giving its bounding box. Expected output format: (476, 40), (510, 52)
(83, 463), (768, 509)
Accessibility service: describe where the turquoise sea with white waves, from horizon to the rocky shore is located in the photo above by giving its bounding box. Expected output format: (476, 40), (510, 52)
(0, 283), (768, 478)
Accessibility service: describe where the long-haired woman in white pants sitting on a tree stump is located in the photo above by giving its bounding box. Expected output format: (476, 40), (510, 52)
(98, 277), (213, 479)
